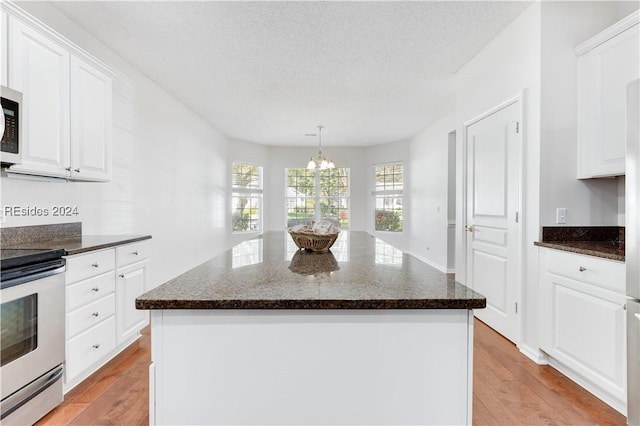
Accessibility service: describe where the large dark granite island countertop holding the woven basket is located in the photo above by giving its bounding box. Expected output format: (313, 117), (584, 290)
(136, 231), (486, 309)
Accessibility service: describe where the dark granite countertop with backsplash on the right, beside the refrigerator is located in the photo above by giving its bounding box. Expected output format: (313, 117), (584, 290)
(534, 226), (625, 262)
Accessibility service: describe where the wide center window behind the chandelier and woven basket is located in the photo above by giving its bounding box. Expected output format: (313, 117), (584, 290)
(285, 167), (349, 229)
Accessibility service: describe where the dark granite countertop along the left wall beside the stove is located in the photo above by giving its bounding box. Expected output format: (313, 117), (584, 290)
(2, 235), (151, 256)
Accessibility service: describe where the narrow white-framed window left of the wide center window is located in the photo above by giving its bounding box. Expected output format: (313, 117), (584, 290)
(231, 163), (262, 232)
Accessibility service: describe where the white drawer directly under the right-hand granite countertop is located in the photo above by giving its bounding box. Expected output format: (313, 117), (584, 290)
(547, 250), (626, 293)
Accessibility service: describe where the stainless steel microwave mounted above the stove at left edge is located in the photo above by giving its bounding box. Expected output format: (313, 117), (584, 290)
(0, 86), (22, 165)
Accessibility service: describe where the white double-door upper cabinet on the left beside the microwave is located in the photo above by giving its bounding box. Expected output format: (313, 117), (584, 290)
(0, 3), (112, 181)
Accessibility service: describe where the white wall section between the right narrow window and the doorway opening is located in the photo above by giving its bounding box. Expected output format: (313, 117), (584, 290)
(407, 113), (456, 271)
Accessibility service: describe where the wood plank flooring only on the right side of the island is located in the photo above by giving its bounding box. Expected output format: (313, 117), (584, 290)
(473, 320), (627, 425)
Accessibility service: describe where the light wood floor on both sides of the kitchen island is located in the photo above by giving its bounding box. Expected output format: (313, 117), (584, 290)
(37, 320), (626, 426)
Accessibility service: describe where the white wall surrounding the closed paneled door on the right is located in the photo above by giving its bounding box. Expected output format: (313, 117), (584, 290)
(456, 2), (540, 356)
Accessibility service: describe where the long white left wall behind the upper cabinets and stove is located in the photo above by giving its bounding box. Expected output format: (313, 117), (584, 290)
(0, 3), (229, 287)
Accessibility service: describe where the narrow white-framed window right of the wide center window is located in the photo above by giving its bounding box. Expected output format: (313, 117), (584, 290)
(373, 163), (403, 232)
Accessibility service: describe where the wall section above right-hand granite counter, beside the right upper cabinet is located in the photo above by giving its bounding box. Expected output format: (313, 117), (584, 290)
(540, 1), (619, 226)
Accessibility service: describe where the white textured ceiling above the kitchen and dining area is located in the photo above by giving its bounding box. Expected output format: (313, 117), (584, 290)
(48, 1), (530, 146)
